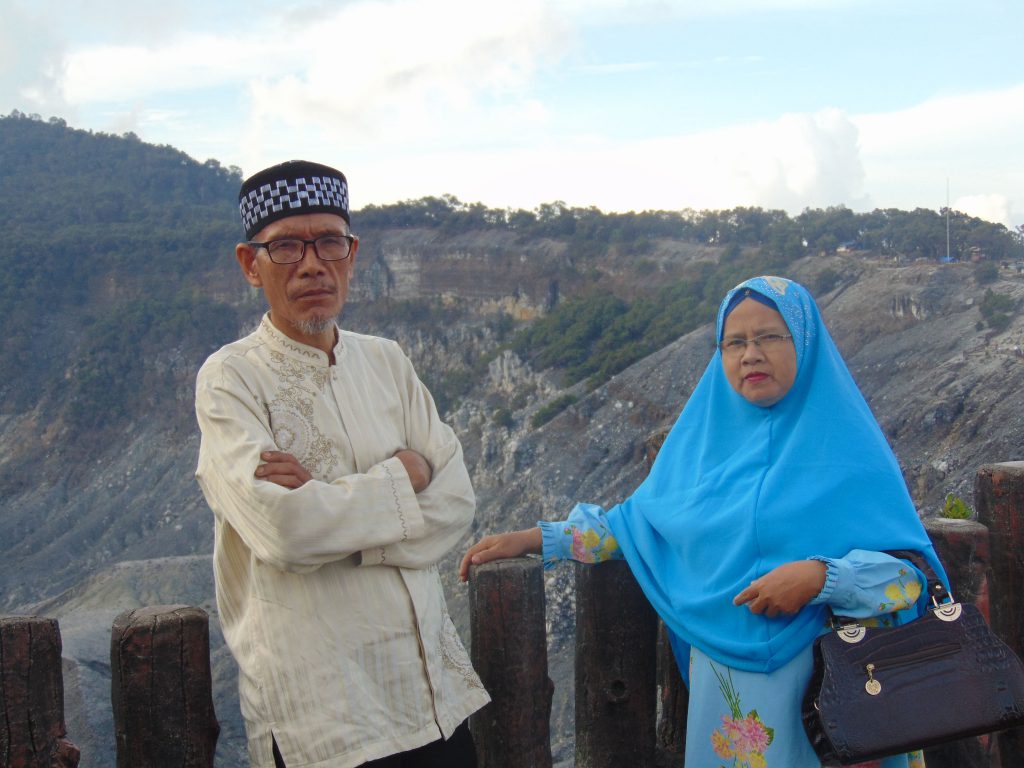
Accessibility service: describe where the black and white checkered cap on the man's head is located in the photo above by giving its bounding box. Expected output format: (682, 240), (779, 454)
(239, 160), (352, 240)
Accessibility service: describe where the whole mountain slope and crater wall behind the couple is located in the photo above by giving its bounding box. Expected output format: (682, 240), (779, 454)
(0, 118), (1024, 768)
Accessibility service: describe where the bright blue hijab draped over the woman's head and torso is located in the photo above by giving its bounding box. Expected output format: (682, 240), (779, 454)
(607, 278), (943, 672)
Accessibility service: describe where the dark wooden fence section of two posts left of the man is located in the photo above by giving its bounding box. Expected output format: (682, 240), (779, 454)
(0, 605), (220, 768)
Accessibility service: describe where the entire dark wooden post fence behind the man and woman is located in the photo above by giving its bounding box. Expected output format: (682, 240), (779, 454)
(0, 462), (1024, 768)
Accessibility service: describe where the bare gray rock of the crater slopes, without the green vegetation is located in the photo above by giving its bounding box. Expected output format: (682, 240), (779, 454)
(0, 250), (1024, 768)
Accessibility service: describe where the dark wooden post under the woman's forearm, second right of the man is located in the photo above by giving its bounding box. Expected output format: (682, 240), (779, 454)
(575, 560), (657, 768)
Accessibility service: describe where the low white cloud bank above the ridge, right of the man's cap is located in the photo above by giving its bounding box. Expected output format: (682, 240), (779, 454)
(335, 105), (863, 213)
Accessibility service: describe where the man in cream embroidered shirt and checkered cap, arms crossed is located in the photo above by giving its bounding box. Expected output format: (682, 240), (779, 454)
(196, 161), (488, 768)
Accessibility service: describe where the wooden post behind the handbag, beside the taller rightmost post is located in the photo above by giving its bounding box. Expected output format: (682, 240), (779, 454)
(925, 517), (998, 768)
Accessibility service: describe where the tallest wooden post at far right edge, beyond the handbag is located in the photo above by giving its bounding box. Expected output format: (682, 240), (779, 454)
(974, 462), (1024, 768)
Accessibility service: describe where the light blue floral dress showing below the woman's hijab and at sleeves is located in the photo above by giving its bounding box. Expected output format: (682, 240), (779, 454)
(539, 504), (925, 768)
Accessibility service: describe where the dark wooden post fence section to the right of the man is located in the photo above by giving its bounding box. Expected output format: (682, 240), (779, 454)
(470, 462), (1024, 768)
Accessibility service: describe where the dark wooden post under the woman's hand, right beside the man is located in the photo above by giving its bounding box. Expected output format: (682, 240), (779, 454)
(469, 558), (554, 768)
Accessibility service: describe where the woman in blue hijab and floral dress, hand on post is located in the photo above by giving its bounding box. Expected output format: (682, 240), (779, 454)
(461, 278), (943, 768)
